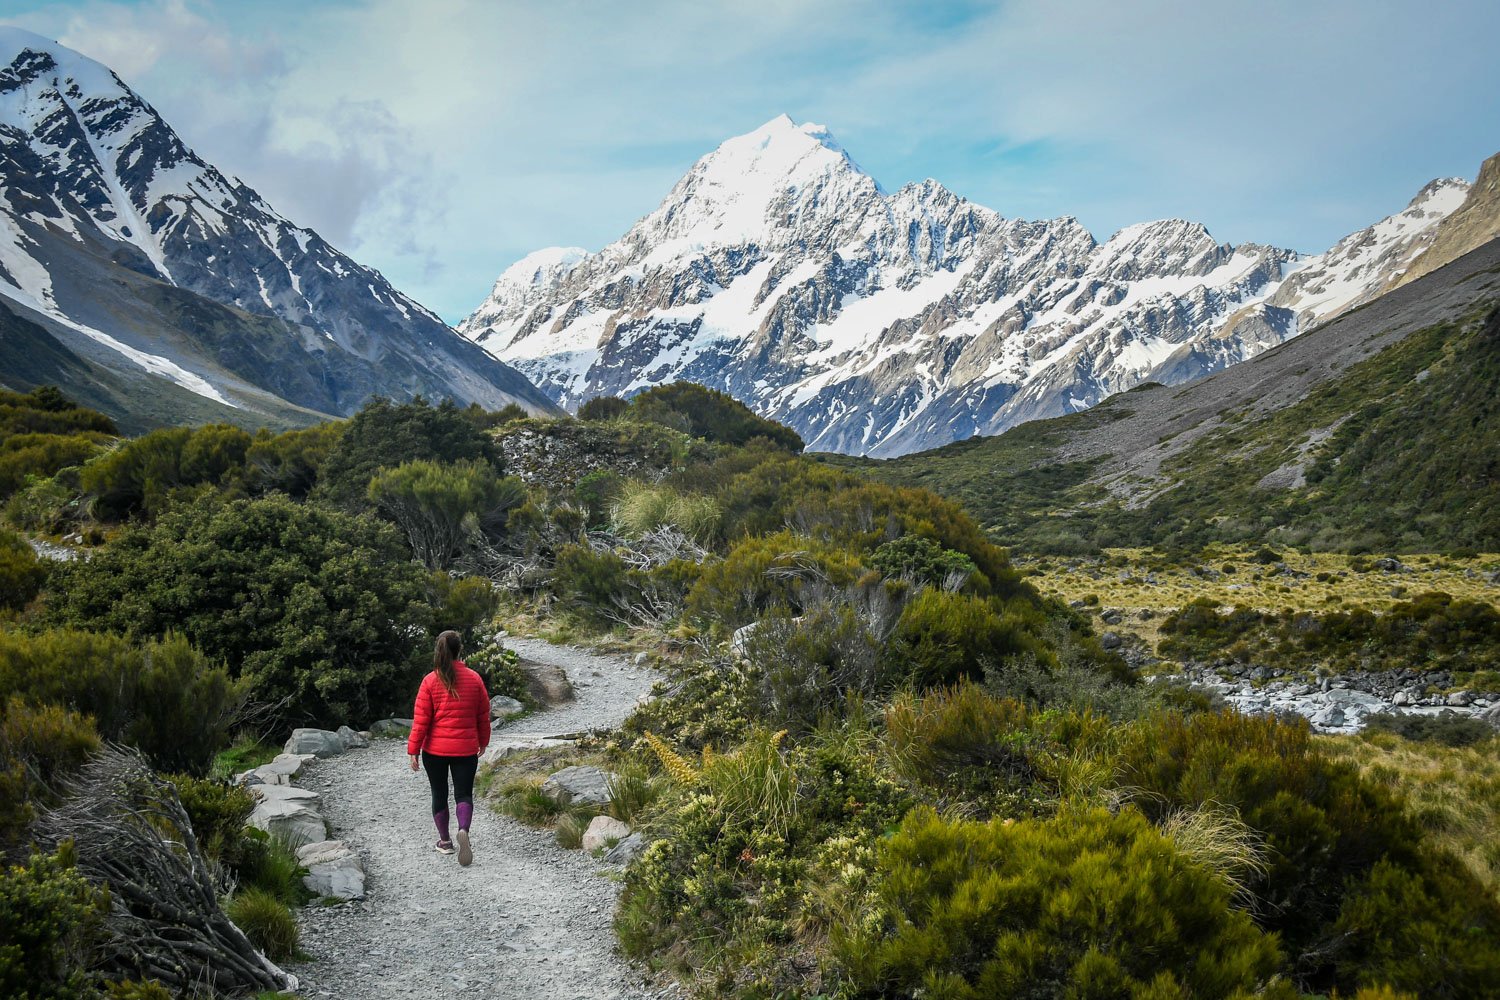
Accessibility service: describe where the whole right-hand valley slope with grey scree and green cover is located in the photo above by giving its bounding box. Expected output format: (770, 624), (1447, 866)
(836, 240), (1500, 552)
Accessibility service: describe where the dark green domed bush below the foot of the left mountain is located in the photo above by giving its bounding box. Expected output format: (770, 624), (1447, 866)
(312, 396), (500, 510)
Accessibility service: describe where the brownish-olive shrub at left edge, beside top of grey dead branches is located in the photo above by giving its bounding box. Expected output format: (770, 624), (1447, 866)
(0, 696), (99, 859)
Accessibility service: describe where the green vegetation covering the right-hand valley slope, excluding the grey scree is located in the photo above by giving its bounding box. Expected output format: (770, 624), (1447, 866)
(846, 312), (1500, 555)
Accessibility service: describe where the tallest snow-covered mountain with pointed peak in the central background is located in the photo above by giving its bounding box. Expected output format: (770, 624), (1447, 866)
(459, 115), (1464, 456)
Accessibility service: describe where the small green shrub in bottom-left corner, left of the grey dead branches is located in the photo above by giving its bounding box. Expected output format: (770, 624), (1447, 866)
(0, 849), (110, 1000)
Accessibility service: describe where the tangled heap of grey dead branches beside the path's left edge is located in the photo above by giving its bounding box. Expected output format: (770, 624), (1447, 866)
(38, 747), (297, 996)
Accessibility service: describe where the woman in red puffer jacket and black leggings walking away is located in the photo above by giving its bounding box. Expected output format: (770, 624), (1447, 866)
(407, 631), (489, 867)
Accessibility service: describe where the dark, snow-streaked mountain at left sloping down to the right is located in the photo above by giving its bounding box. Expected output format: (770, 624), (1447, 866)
(0, 27), (552, 418)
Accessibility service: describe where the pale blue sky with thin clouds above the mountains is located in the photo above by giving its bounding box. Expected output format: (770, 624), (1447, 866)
(0, 0), (1500, 321)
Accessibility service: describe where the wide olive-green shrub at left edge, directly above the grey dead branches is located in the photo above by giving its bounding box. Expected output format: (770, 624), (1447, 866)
(0, 630), (246, 774)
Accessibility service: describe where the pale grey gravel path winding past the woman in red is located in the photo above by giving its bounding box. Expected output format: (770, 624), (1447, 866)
(291, 639), (656, 1000)
